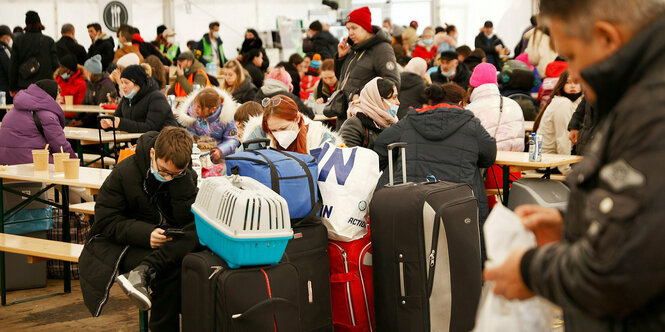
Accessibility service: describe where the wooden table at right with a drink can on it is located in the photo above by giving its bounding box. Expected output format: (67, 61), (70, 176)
(494, 151), (582, 205)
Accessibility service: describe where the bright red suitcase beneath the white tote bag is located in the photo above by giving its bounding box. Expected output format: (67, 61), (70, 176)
(328, 234), (376, 332)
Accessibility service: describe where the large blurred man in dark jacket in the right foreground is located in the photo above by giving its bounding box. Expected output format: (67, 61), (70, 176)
(485, 0), (665, 332)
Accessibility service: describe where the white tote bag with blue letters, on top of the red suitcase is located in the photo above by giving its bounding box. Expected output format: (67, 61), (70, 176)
(312, 143), (380, 242)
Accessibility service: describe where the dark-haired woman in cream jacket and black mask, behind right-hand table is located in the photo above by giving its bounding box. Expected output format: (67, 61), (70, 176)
(533, 70), (582, 175)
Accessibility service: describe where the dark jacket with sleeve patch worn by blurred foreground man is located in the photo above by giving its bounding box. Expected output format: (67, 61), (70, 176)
(521, 15), (665, 332)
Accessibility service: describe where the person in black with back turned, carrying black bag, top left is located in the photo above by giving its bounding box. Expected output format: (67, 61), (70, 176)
(9, 10), (60, 97)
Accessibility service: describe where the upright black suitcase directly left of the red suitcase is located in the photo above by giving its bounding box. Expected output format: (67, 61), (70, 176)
(282, 217), (333, 332)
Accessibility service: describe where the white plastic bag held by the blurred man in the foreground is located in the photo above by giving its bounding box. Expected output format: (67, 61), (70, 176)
(474, 204), (556, 332)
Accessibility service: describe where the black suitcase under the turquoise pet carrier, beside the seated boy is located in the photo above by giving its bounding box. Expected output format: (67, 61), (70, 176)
(182, 251), (301, 332)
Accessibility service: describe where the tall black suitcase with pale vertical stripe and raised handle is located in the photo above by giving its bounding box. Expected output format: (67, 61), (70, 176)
(370, 143), (482, 332)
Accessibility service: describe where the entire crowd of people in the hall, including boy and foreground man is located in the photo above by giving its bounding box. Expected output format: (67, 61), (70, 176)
(0, 0), (665, 331)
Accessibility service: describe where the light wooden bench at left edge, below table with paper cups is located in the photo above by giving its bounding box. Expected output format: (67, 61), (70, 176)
(0, 233), (83, 263)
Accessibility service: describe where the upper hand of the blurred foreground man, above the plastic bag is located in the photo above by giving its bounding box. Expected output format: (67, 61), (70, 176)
(515, 205), (563, 247)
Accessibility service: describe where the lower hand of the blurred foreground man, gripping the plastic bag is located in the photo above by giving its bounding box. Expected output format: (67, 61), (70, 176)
(483, 249), (534, 300)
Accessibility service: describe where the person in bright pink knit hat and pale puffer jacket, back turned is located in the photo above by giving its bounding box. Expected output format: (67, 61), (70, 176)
(466, 63), (524, 210)
